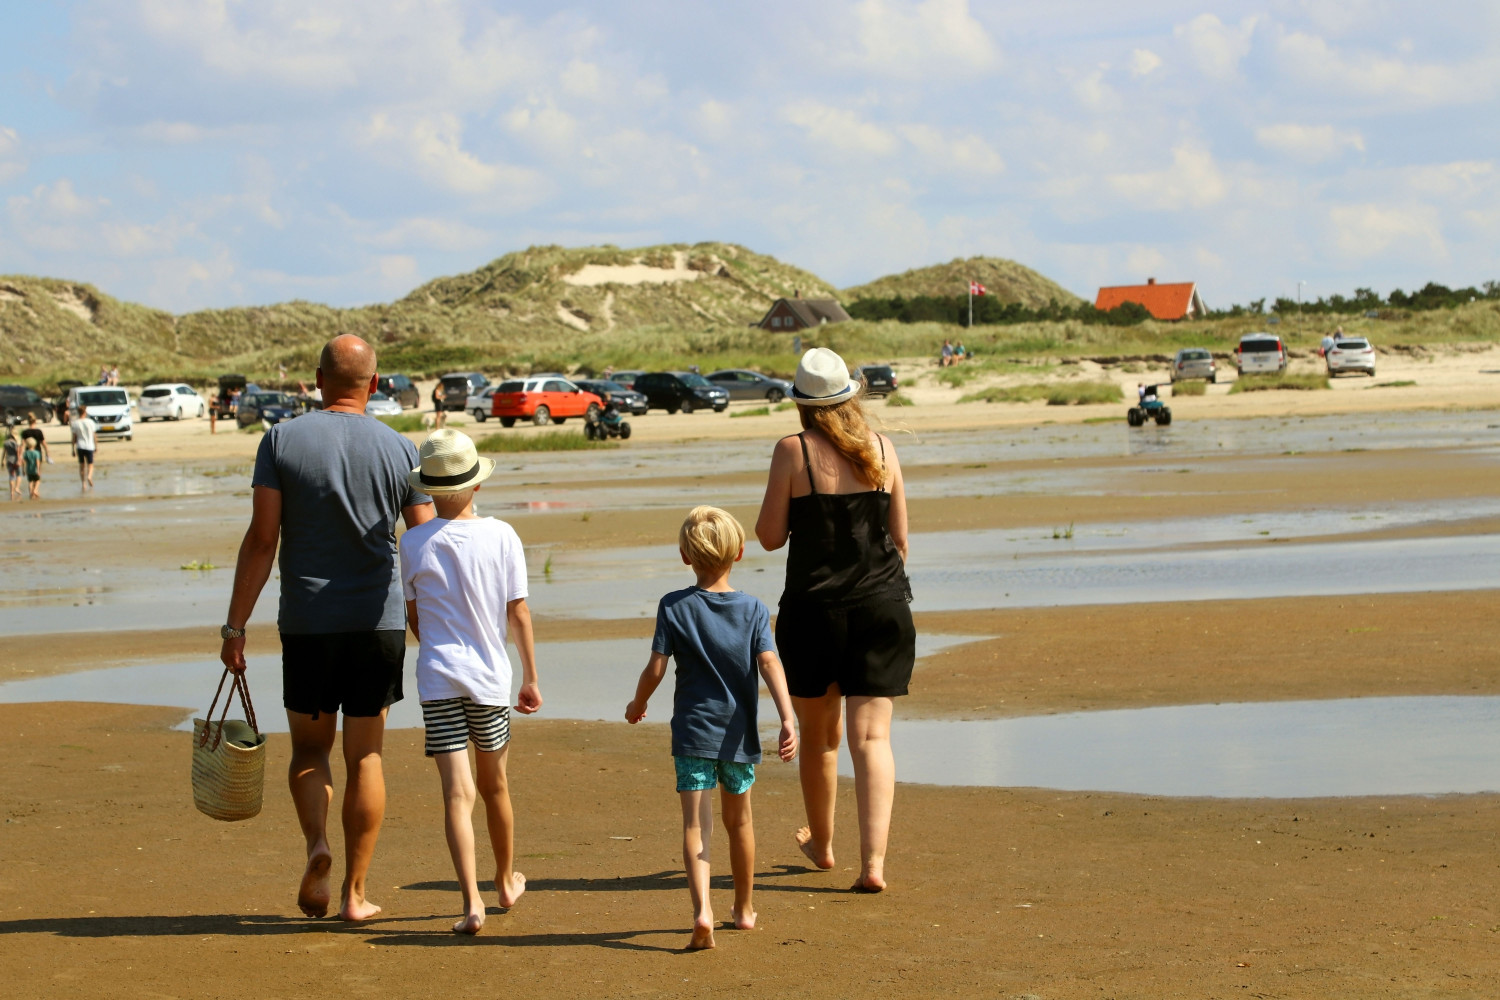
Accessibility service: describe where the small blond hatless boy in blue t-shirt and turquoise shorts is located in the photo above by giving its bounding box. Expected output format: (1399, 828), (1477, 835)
(626, 507), (797, 949)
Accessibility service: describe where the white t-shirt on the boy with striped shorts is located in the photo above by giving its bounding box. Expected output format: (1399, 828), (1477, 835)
(401, 517), (527, 705)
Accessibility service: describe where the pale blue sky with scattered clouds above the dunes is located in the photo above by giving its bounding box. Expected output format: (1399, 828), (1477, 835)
(0, 0), (1500, 312)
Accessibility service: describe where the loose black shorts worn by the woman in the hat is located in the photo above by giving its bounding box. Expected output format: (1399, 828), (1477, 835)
(776, 597), (917, 699)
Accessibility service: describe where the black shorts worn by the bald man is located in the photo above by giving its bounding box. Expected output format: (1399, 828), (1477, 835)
(282, 628), (407, 718)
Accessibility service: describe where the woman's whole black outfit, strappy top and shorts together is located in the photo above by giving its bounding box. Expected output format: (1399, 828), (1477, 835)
(776, 435), (917, 699)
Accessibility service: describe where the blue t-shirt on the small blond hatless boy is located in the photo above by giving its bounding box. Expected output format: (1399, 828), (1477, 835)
(651, 586), (776, 763)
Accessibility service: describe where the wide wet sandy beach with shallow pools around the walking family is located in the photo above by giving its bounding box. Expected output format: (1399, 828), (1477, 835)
(0, 355), (1500, 999)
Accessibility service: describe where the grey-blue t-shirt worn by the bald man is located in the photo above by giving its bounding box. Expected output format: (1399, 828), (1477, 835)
(251, 409), (429, 636)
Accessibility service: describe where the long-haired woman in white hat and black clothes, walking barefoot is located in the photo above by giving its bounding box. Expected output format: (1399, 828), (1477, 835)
(755, 348), (917, 892)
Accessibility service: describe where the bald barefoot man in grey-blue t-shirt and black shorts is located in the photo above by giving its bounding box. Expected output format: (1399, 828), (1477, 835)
(219, 334), (432, 921)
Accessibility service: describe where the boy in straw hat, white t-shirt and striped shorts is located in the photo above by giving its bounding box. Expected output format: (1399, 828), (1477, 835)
(401, 430), (542, 934)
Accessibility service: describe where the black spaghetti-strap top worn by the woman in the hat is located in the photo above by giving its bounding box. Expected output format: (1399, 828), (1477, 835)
(782, 435), (912, 604)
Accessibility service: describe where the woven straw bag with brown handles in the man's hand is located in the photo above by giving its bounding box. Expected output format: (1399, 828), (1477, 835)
(192, 669), (266, 822)
